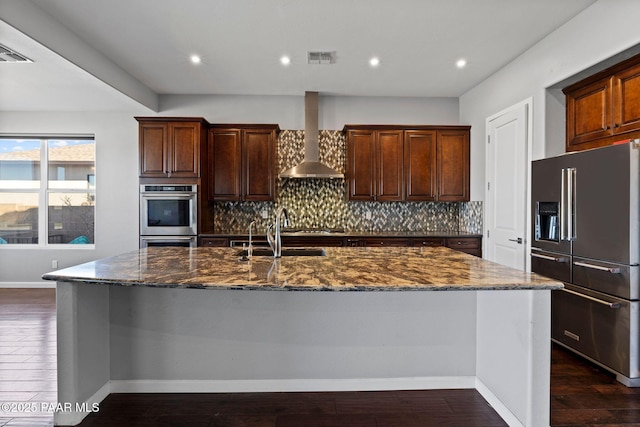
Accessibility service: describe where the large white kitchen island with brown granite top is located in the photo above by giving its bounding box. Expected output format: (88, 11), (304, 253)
(44, 247), (562, 426)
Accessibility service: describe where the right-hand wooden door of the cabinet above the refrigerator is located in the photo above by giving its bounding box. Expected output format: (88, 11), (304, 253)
(613, 65), (640, 133)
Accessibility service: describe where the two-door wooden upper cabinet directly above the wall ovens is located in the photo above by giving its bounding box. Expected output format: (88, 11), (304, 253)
(136, 117), (208, 178)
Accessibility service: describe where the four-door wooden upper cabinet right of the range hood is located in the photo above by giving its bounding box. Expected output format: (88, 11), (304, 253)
(344, 125), (470, 202)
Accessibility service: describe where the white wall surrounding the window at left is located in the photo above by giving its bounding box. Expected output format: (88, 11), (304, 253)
(0, 111), (141, 286)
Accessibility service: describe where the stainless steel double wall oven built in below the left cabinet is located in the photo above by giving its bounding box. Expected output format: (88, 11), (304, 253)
(140, 184), (198, 248)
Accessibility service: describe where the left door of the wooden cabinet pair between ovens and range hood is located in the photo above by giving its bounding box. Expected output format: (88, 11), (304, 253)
(208, 129), (242, 201)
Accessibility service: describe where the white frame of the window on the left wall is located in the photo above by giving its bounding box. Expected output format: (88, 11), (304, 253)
(0, 134), (97, 250)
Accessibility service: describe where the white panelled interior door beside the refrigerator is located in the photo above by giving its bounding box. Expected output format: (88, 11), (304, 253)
(485, 100), (531, 270)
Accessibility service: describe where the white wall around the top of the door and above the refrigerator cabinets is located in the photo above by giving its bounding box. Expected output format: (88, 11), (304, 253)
(460, 0), (640, 200)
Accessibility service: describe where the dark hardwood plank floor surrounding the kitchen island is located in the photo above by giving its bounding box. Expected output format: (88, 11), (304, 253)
(0, 289), (640, 427)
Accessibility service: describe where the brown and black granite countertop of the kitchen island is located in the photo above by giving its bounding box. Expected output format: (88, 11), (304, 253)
(43, 247), (563, 291)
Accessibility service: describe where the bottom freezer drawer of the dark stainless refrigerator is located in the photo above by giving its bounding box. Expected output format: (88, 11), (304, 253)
(551, 284), (640, 378)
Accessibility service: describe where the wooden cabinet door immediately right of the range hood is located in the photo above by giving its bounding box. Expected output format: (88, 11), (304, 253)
(347, 130), (376, 201)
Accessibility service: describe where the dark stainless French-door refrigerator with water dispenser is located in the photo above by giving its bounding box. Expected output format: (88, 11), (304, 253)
(531, 140), (640, 387)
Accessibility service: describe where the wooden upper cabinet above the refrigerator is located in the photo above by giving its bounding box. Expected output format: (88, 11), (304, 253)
(563, 56), (640, 151)
